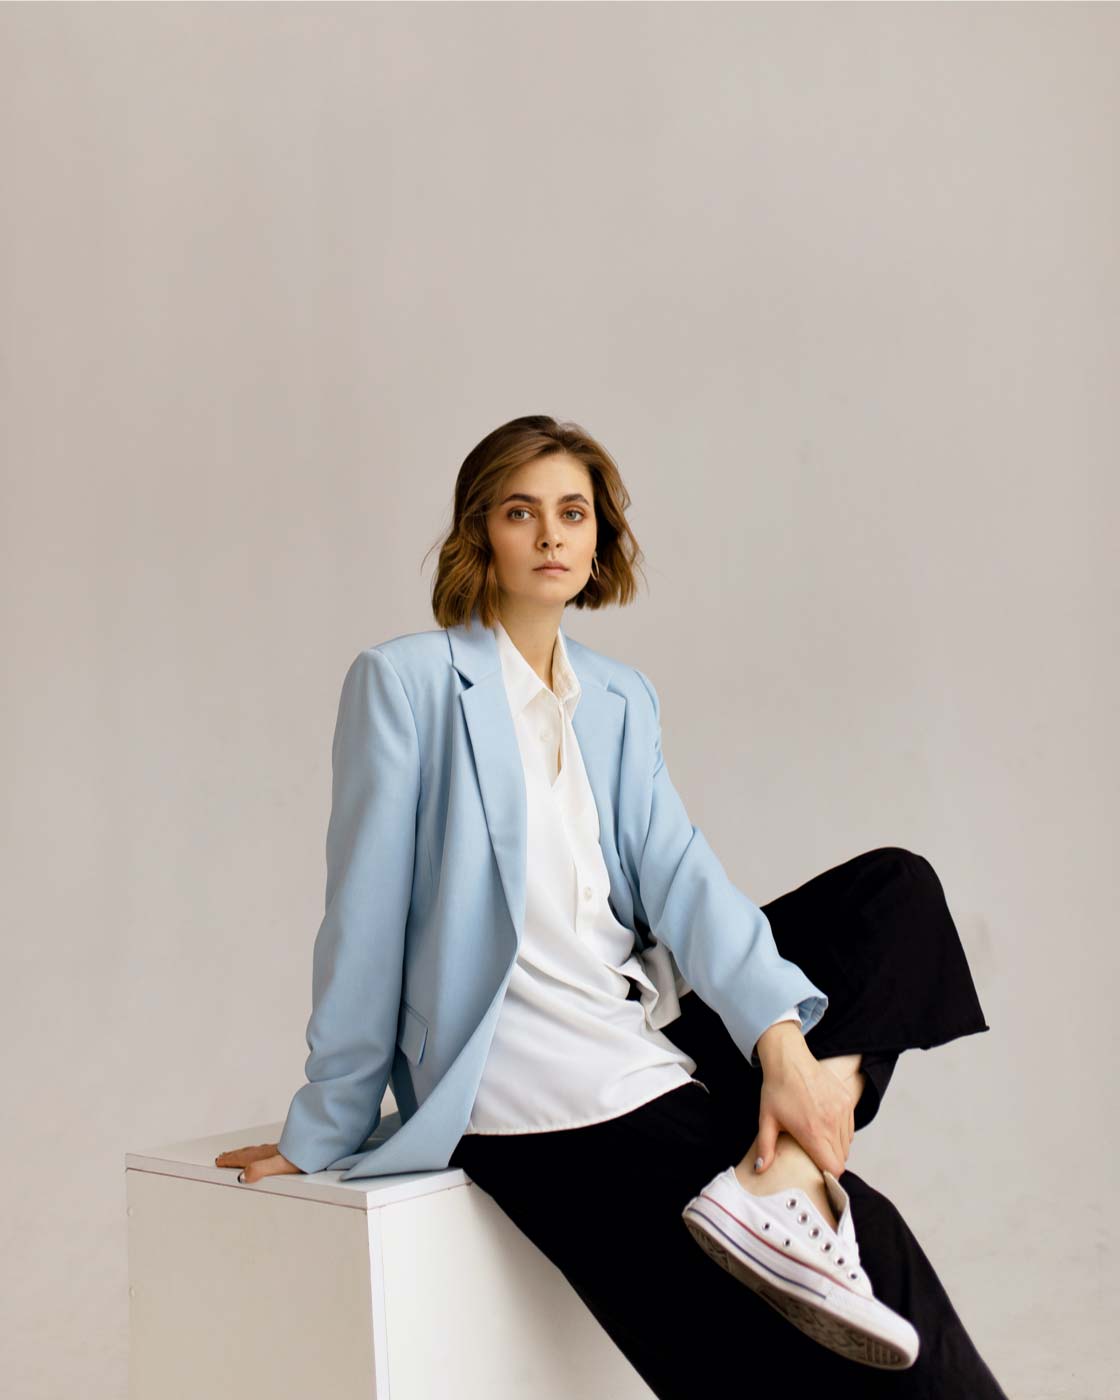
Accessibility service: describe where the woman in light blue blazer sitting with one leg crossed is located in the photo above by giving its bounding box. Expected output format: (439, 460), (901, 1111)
(217, 416), (1004, 1400)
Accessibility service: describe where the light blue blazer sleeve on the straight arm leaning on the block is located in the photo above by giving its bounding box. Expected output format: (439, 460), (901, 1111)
(277, 648), (420, 1172)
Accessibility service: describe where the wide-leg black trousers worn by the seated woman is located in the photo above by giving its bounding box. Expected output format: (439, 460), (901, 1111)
(451, 846), (1007, 1400)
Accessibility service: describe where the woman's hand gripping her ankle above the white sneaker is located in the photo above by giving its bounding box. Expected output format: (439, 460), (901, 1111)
(757, 1021), (855, 1176)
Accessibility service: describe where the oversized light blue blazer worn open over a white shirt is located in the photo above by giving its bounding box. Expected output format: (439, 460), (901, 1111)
(279, 615), (827, 1180)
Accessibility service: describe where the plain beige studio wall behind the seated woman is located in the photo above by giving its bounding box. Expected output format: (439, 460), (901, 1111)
(0, 4), (1120, 1400)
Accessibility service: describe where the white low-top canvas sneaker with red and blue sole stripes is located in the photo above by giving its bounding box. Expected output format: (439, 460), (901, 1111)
(680, 1166), (918, 1371)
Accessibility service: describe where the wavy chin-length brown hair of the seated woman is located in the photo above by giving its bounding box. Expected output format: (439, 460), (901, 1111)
(424, 413), (643, 627)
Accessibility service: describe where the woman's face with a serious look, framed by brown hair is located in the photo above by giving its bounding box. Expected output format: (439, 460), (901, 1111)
(486, 452), (598, 612)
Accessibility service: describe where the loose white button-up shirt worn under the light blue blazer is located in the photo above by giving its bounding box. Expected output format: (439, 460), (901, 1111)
(465, 622), (799, 1133)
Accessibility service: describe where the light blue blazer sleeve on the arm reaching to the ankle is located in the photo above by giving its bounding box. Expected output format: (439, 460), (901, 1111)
(637, 671), (829, 1067)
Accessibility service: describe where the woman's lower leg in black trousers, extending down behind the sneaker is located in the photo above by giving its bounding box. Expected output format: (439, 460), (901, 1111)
(451, 1064), (1007, 1400)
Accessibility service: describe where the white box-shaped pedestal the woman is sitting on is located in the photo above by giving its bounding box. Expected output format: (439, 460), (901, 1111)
(125, 1123), (652, 1400)
